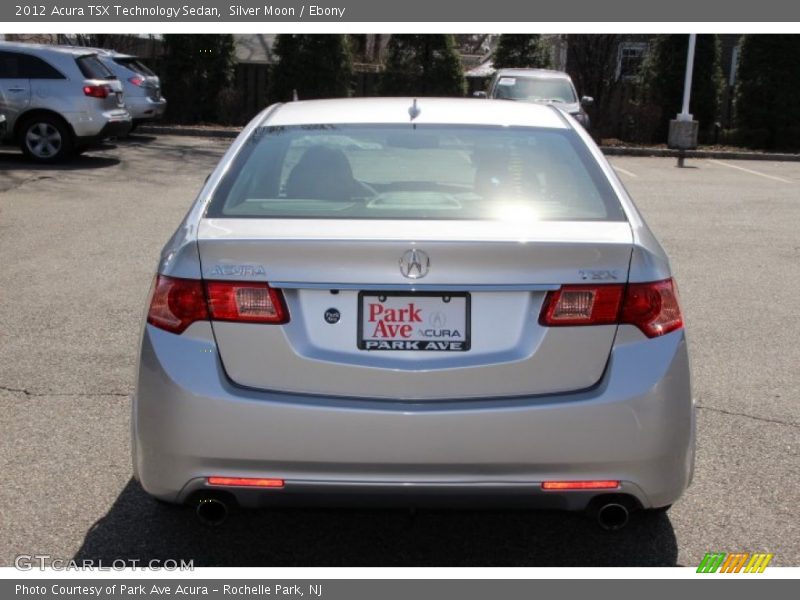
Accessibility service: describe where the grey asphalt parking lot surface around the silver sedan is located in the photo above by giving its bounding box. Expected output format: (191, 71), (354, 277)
(0, 135), (800, 566)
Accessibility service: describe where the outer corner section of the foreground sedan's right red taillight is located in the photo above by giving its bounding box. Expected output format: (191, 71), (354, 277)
(620, 279), (683, 337)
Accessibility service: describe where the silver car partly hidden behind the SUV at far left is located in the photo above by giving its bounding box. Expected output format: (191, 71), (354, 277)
(92, 49), (167, 129)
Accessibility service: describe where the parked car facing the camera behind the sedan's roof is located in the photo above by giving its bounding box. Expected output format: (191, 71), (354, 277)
(478, 69), (594, 129)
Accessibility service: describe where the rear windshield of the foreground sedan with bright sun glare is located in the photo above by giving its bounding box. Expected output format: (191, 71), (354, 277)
(207, 125), (625, 221)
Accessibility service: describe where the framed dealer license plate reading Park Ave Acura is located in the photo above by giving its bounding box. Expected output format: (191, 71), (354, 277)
(358, 292), (470, 352)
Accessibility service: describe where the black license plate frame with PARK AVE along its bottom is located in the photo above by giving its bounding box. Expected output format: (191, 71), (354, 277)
(356, 290), (472, 353)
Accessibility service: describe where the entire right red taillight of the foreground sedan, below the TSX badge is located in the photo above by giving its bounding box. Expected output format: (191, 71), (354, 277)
(539, 279), (683, 338)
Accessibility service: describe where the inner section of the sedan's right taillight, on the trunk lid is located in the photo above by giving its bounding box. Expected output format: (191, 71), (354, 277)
(539, 284), (625, 326)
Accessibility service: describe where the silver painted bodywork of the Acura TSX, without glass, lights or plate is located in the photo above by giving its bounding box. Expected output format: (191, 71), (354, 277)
(132, 98), (695, 510)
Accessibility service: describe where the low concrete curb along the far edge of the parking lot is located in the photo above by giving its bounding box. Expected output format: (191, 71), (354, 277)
(141, 125), (800, 162)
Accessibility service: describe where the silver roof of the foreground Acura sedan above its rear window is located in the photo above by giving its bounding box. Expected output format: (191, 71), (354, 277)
(263, 97), (570, 129)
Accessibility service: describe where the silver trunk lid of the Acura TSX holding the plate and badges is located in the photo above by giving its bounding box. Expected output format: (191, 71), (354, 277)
(198, 218), (632, 400)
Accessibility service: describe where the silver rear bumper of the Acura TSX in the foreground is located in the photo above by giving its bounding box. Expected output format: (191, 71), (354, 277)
(132, 323), (694, 510)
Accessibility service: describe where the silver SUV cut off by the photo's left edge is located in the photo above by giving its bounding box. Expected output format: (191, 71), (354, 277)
(0, 42), (131, 162)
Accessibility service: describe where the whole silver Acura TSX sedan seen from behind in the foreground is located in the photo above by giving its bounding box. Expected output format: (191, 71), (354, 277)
(132, 98), (695, 528)
